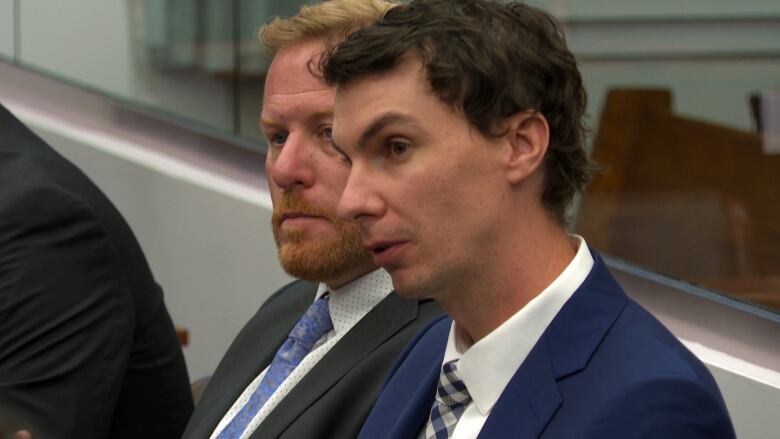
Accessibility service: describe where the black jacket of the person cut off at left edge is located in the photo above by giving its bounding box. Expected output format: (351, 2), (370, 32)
(0, 106), (192, 439)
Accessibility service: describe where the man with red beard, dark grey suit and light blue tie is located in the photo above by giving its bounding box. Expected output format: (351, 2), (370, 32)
(179, 0), (441, 439)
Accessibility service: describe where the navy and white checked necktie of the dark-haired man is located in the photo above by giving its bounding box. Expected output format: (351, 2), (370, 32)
(425, 360), (471, 439)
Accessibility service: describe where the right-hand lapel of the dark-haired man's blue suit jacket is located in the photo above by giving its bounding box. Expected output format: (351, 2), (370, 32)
(479, 253), (627, 439)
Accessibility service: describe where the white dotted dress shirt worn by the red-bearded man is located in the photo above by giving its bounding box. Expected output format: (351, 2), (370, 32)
(211, 269), (393, 439)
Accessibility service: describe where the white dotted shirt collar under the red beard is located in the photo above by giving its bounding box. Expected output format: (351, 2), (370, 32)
(314, 268), (393, 335)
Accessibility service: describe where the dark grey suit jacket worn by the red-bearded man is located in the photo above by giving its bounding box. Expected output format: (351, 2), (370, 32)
(184, 281), (442, 439)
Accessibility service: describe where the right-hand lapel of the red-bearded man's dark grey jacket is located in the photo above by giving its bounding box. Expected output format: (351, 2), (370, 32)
(252, 293), (418, 438)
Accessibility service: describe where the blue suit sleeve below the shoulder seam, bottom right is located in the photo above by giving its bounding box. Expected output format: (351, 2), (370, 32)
(583, 376), (736, 439)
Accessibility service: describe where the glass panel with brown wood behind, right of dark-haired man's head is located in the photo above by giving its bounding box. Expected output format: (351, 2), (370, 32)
(562, 1), (780, 311)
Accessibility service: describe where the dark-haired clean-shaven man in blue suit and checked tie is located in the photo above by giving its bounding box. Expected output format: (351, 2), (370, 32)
(323, 0), (734, 439)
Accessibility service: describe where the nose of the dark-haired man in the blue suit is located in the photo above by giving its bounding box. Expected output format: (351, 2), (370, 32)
(336, 164), (385, 223)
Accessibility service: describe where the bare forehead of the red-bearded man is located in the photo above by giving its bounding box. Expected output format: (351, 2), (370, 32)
(264, 40), (332, 97)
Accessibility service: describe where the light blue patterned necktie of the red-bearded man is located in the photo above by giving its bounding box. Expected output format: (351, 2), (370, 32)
(217, 296), (333, 439)
